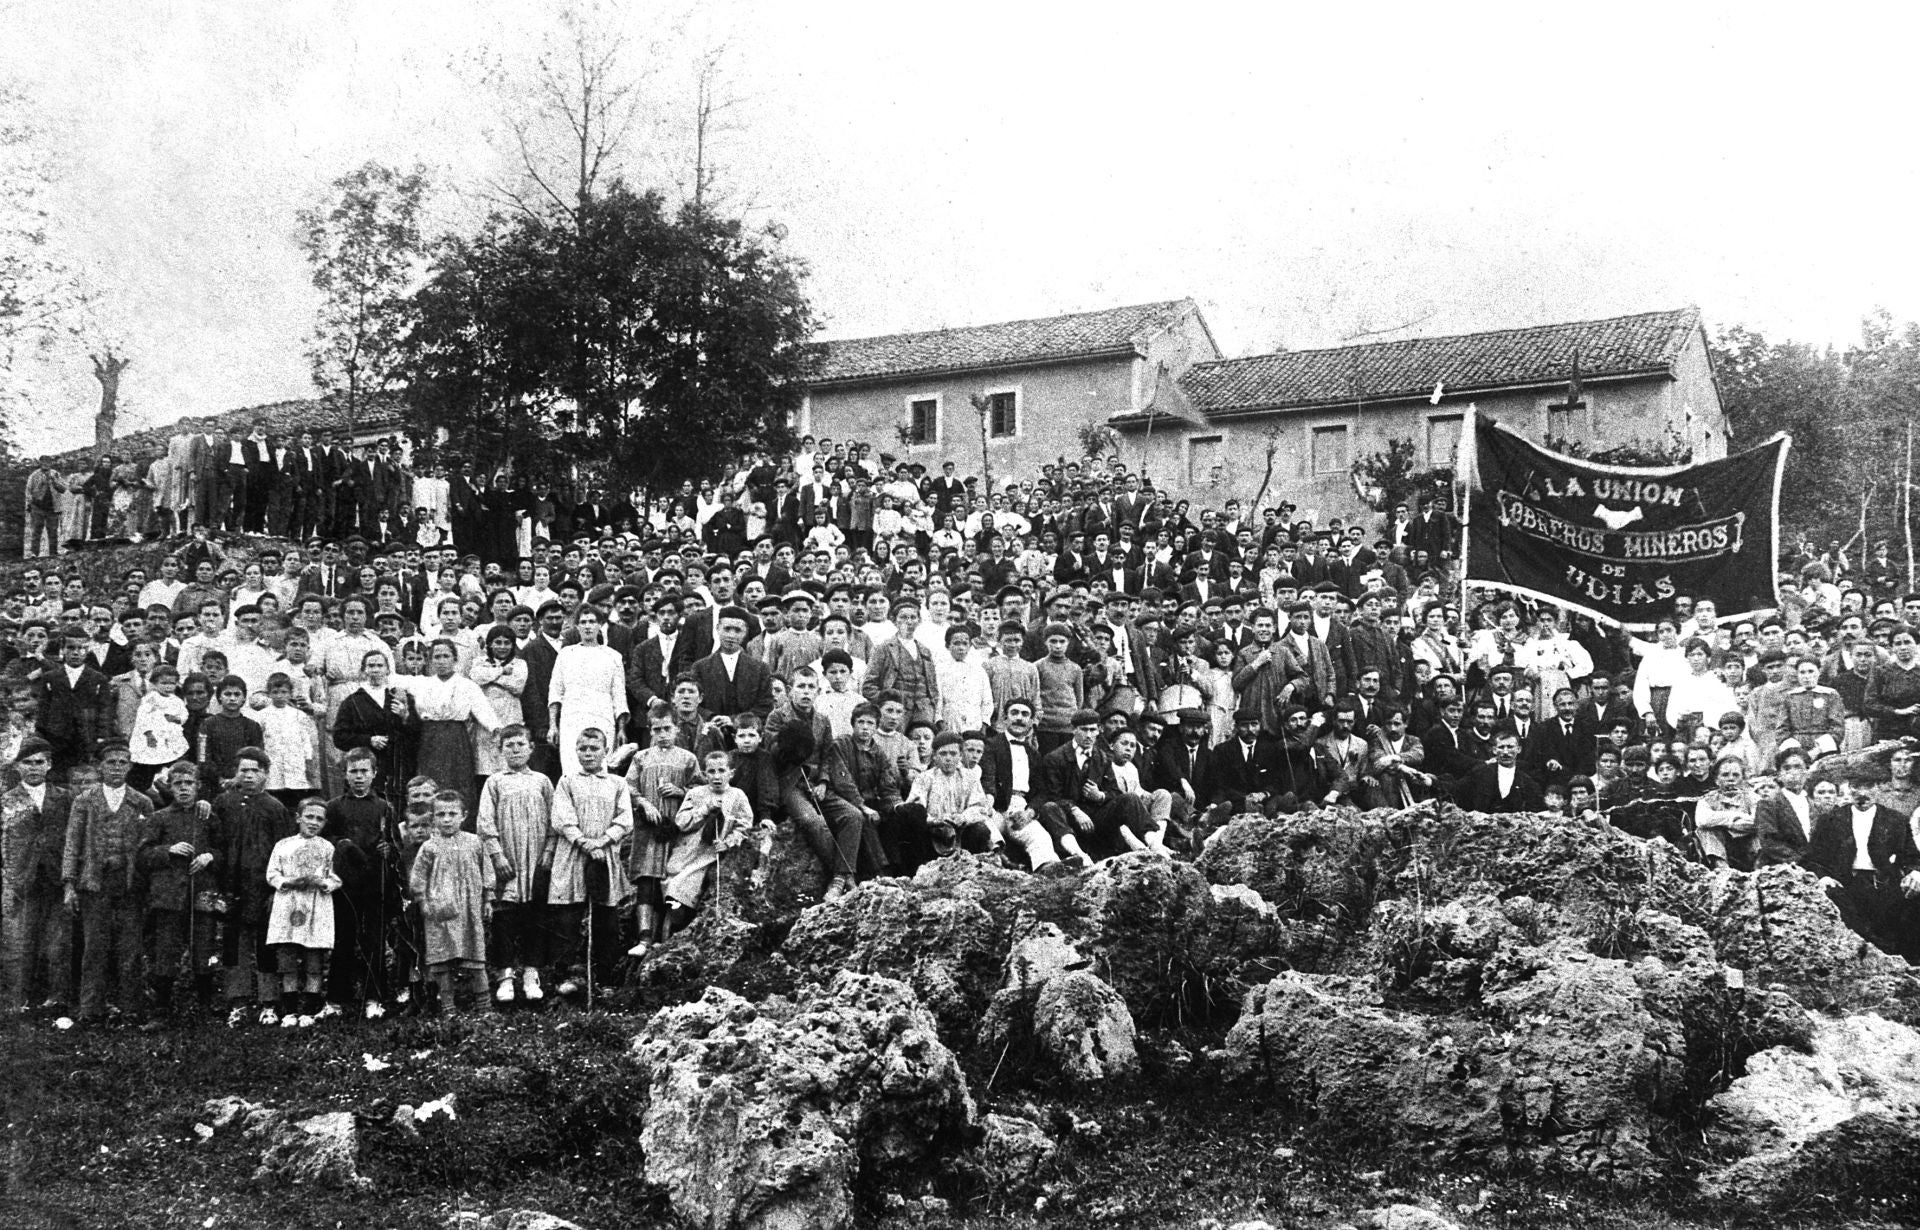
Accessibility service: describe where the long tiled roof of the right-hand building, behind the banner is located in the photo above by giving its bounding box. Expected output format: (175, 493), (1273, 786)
(1181, 307), (1699, 414)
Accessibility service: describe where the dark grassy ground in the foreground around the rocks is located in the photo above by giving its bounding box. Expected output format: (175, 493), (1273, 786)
(0, 1007), (1912, 1230)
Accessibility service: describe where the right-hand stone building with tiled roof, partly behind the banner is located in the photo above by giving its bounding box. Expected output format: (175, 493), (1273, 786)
(1114, 307), (1726, 522)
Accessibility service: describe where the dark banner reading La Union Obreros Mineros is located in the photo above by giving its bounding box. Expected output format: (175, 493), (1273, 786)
(1463, 416), (1789, 626)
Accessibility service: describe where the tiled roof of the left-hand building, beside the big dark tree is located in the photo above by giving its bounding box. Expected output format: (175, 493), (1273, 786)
(814, 299), (1194, 384)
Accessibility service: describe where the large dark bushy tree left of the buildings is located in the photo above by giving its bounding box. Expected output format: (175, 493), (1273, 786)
(405, 180), (814, 489)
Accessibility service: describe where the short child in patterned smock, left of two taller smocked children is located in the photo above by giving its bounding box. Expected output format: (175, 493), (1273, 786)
(411, 791), (493, 1011)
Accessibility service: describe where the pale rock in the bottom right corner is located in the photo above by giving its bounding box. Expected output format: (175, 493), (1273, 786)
(1701, 1013), (1920, 1207)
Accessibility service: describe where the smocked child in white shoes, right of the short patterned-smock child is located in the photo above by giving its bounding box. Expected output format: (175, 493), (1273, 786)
(478, 725), (555, 1004)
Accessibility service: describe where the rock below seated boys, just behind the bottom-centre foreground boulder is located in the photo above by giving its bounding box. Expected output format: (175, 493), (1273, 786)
(783, 881), (1004, 1036)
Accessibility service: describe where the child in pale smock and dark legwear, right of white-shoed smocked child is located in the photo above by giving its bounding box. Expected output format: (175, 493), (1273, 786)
(547, 727), (634, 996)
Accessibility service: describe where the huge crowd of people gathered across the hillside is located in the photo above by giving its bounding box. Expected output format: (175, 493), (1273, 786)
(0, 422), (1920, 1027)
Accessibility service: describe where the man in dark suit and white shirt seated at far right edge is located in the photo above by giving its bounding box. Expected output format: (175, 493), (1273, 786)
(1807, 769), (1920, 952)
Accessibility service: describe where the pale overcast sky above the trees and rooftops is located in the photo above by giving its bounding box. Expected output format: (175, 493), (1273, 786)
(0, 0), (1920, 451)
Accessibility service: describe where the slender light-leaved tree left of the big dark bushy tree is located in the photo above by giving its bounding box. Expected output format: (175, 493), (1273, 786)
(300, 163), (426, 432)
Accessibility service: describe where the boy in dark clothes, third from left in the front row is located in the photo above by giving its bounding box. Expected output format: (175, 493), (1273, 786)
(140, 759), (219, 1017)
